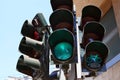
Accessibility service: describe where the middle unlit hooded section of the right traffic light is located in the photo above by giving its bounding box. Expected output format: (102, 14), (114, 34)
(81, 21), (105, 48)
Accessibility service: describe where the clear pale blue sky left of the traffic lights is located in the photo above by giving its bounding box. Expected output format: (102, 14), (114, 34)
(0, 0), (52, 80)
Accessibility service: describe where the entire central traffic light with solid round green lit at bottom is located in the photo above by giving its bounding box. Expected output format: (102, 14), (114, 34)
(48, 0), (76, 64)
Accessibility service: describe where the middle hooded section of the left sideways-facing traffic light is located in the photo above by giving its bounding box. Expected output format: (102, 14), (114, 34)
(19, 37), (44, 59)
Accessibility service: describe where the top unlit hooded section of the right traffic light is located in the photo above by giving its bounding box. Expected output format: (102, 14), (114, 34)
(79, 5), (101, 31)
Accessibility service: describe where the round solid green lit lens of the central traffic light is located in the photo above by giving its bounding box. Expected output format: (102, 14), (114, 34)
(54, 42), (73, 61)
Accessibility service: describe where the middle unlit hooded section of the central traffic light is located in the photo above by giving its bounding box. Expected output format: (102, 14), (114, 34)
(49, 9), (73, 32)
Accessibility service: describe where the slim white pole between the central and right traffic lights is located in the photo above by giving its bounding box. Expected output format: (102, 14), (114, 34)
(73, 5), (82, 80)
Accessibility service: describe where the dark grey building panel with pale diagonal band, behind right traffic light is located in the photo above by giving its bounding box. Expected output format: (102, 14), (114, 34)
(100, 8), (120, 61)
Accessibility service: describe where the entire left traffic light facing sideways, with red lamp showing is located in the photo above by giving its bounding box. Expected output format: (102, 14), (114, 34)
(16, 13), (49, 80)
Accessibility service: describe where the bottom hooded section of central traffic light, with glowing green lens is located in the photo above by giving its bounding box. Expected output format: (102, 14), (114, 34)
(48, 29), (74, 63)
